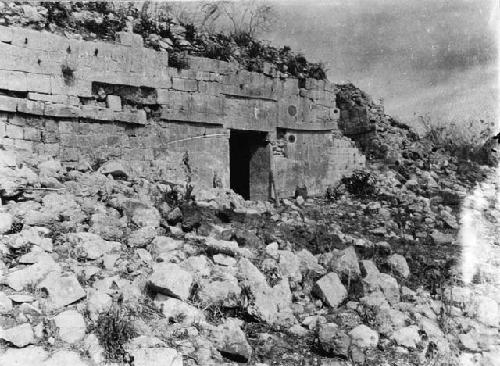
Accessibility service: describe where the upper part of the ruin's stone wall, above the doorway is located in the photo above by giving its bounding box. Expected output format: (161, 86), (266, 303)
(0, 27), (338, 129)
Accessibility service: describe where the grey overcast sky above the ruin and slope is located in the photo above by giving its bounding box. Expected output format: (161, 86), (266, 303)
(263, 0), (498, 129)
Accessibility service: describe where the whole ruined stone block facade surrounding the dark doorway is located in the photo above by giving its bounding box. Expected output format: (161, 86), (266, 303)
(0, 27), (365, 200)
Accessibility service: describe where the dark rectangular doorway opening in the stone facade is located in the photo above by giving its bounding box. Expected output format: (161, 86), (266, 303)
(229, 130), (271, 201)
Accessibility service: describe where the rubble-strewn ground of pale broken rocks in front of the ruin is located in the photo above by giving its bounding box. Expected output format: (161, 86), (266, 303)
(0, 118), (500, 366)
